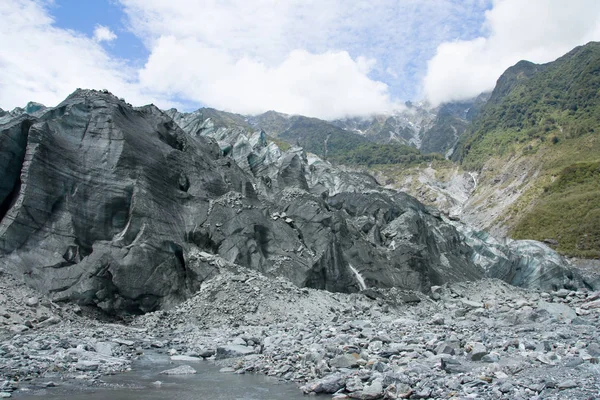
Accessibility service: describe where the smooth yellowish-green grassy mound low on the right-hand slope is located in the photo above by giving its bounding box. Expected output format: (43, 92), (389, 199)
(513, 161), (600, 257)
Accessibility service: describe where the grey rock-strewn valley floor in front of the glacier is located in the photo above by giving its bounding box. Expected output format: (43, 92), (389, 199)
(0, 263), (600, 399)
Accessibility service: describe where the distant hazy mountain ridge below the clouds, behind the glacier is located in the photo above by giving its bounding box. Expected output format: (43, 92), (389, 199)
(247, 93), (490, 161)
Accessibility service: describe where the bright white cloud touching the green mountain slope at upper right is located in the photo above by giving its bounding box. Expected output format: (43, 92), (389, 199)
(423, 0), (600, 104)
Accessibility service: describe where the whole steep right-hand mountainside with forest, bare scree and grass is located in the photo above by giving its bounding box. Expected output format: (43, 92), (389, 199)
(452, 42), (600, 257)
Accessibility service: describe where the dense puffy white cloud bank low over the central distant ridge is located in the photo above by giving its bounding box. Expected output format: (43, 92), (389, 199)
(140, 36), (393, 119)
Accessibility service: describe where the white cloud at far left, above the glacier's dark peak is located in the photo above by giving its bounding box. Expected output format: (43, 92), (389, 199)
(0, 0), (173, 109)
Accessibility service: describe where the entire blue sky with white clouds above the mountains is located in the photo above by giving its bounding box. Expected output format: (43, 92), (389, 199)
(0, 0), (600, 119)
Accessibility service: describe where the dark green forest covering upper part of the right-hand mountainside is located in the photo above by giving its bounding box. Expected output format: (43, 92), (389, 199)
(453, 43), (600, 169)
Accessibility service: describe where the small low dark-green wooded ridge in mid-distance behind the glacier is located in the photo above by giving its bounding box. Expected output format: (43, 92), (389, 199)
(331, 143), (444, 167)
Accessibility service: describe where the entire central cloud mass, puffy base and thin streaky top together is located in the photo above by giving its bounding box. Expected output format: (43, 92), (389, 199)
(120, 0), (488, 118)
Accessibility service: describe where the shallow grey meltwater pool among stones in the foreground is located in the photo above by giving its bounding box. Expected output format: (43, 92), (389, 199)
(14, 357), (316, 400)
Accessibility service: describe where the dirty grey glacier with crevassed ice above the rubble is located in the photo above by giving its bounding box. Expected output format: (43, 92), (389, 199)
(0, 90), (584, 314)
